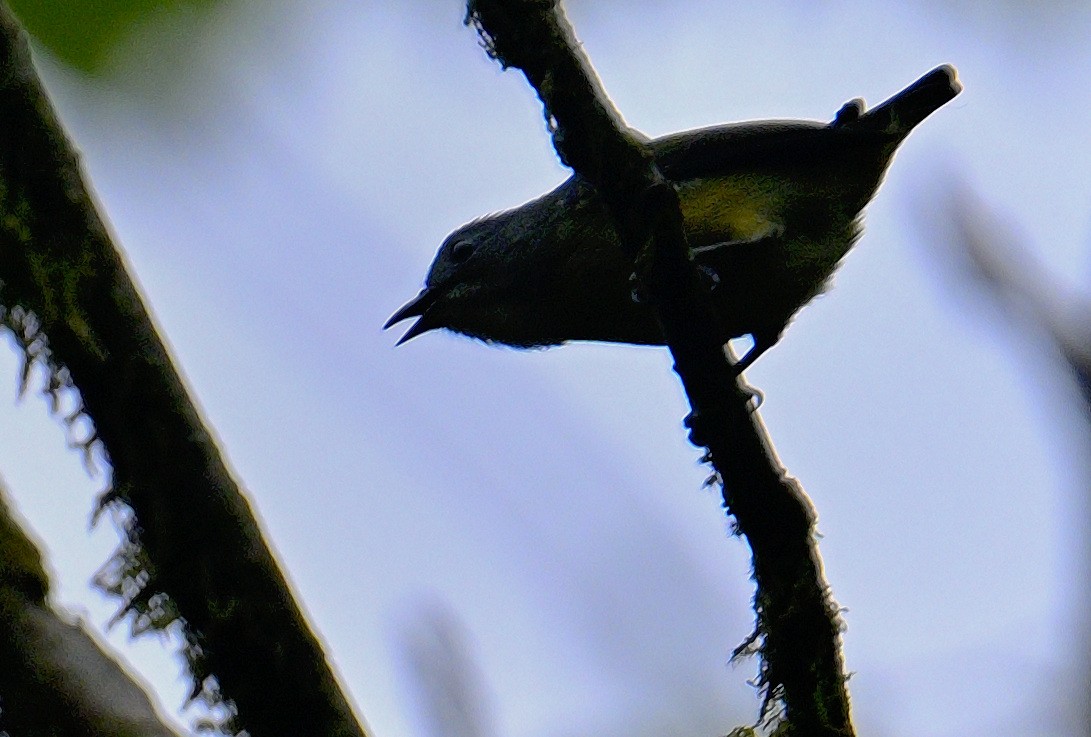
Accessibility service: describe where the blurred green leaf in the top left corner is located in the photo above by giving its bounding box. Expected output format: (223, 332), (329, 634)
(9, 0), (216, 73)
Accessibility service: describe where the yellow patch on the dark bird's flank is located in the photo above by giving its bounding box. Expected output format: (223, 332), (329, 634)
(679, 174), (786, 242)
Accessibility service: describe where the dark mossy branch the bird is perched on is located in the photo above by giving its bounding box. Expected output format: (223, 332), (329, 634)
(467, 0), (852, 736)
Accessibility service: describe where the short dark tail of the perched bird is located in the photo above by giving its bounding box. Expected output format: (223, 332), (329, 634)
(831, 64), (962, 141)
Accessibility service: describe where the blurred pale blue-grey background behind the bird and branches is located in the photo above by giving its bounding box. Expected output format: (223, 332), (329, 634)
(0, 0), (1091, 737)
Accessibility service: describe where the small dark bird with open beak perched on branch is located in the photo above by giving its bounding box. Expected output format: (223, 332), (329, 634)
(384, 64), (962, 373)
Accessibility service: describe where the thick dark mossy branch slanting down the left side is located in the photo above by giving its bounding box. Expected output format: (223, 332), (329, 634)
(0, 4), (364, 736)
